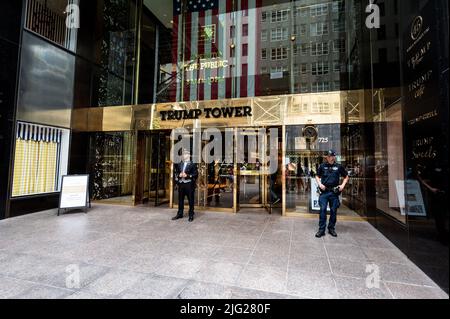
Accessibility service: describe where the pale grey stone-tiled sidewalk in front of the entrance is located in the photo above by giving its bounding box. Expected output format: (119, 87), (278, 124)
(0, 205), (448, 299)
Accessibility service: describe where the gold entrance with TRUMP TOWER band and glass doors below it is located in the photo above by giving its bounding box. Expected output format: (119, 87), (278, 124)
(72, 90), (382, 220)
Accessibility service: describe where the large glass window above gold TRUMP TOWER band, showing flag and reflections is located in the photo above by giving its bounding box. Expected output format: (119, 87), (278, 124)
(150, 0), (360, 102)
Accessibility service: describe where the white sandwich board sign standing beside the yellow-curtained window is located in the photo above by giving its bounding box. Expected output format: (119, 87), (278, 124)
(58, 175), (91, 216)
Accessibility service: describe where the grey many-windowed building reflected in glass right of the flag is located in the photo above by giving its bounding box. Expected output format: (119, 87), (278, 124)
(259, 1), (348, 94)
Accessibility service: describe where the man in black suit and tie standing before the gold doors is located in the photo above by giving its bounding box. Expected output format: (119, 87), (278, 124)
(172, 150), (198, 222)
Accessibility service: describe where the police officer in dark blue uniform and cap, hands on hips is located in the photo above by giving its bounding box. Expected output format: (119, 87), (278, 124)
(316, 150), (349, 238)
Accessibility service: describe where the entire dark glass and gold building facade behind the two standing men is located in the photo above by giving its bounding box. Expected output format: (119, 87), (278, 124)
(0, 0), (448, 294)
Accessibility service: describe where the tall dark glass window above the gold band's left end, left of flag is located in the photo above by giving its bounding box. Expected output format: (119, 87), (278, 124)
(76, 0), (139, 107)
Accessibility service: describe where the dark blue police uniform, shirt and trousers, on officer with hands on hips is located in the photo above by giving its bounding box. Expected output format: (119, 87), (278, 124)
(317, 158), (348, 232)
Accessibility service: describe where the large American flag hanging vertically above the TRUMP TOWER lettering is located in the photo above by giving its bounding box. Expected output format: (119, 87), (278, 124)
(171, 0), (262, 101)
